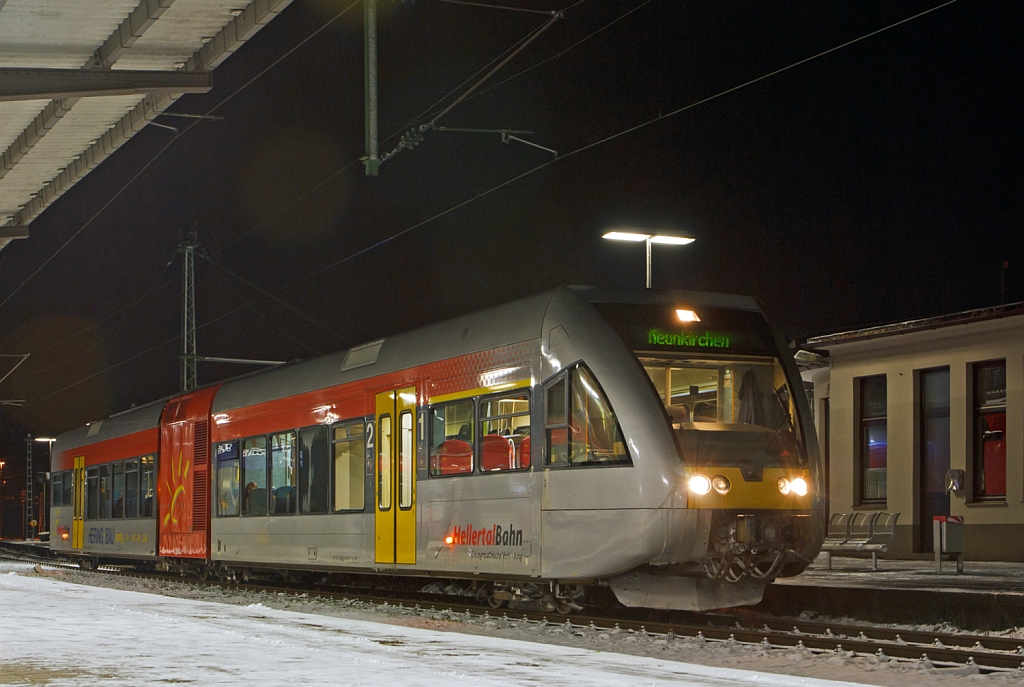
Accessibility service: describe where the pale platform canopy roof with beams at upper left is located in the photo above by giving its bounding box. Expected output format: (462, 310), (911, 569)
(0, 0), (292, 249)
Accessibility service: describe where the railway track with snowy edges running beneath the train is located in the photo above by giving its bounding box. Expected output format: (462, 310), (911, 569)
(9, 561), (1024, 673)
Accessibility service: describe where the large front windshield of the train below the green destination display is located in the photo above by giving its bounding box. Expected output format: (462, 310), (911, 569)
(638, 354), (807, 468)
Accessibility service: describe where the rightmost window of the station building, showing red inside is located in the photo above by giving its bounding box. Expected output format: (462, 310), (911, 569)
(974, 360), (1007, 501)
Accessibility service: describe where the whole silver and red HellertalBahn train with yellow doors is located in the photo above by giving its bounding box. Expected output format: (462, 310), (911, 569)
(49, 287), (824, 613)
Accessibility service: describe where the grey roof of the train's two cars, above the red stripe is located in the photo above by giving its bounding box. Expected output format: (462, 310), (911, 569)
(54, 286), (761, 452)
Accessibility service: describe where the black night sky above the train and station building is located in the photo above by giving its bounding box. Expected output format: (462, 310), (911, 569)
(0, 0), (1024, 438)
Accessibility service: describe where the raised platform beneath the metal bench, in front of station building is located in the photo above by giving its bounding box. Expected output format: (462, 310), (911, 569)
(757, 555), (1024, 630)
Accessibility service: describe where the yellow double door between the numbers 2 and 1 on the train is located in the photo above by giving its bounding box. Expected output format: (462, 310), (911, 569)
(375, 387), (416, 564)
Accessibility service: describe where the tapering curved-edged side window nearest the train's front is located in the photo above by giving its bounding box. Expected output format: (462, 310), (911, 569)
(547, 364), (632, 466)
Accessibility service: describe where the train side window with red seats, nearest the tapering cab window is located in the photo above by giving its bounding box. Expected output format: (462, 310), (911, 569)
(480, 391), (529, 472)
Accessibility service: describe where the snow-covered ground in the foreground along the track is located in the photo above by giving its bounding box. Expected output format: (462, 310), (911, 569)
(0, 561), (1021, 687)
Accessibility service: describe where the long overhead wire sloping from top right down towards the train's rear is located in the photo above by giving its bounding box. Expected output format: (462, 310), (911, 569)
(29, 0), (957, 400)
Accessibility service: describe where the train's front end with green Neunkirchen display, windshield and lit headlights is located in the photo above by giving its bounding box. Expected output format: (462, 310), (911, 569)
(588, 292), (824, 605)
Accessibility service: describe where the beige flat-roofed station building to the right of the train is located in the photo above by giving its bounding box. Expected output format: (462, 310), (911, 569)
(797, 302), (1024, 561)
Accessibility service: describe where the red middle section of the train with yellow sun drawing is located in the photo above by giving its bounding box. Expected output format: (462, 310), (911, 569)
(157, 385), (220, 558)
